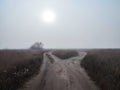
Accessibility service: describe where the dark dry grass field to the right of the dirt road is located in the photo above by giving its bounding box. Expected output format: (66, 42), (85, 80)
(81, 50), (120, 90)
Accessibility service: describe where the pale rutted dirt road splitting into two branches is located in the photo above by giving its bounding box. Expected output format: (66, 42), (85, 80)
(20, 52), (98, 90)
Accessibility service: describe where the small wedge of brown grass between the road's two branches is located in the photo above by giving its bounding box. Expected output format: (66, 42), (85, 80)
(53, 50), (78, 59)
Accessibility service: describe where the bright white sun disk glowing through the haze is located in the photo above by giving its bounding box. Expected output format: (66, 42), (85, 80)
(42, 11), (55, 23)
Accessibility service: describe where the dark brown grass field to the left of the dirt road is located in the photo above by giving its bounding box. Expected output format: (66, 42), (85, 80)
(0, 50), (43, 90)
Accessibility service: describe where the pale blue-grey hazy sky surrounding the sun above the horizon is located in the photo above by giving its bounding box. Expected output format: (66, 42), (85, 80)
(0, 0), (120, 49)
